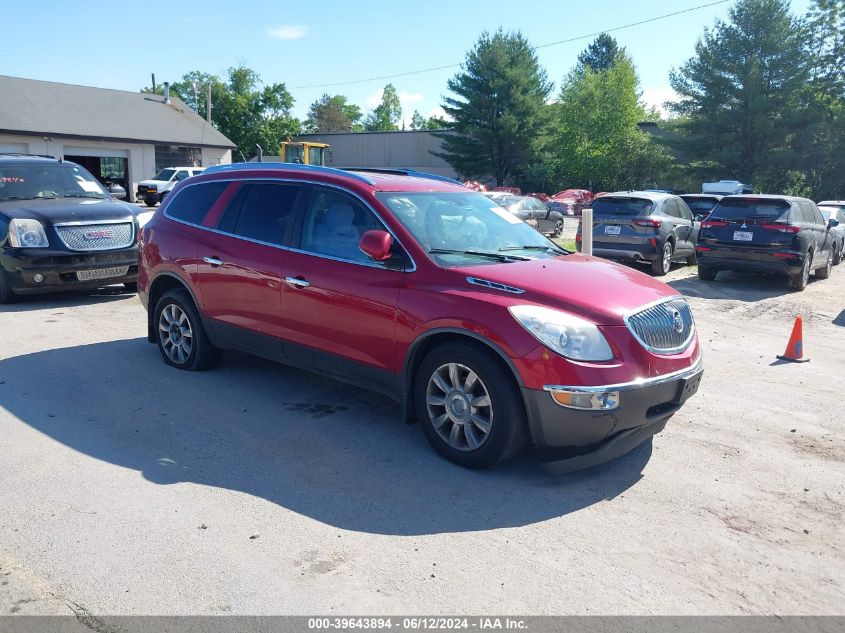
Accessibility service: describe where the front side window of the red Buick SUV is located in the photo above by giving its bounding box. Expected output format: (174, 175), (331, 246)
(301, 187), (384, 262)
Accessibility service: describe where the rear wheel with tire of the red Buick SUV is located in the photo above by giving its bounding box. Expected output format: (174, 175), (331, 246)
(153, 289), (221, 371)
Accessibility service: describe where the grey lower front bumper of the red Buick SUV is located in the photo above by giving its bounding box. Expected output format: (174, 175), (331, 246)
(522, 356), (704, 472)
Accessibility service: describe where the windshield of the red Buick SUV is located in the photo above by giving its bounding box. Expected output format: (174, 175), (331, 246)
(376, 191), (567, 266)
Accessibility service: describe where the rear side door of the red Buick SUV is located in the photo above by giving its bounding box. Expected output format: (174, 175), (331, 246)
(197, 182), (302, 359)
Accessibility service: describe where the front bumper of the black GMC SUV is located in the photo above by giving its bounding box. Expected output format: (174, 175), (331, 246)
(0, 246), (138, 295)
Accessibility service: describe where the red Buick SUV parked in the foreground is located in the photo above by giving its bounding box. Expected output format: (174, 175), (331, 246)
(138, 163), (702, 471)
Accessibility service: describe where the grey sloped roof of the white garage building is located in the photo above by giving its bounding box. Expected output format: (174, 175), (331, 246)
(0, 75), (235, 148)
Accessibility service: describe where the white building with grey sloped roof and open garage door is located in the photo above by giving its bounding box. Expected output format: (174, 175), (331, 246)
(0, 75), (235, 201)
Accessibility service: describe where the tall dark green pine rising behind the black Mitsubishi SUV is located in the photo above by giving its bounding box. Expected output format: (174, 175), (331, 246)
(670, 0), (808, 190)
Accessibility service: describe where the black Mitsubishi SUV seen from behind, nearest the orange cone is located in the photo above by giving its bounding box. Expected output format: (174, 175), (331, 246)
(697, 195), (839, 290)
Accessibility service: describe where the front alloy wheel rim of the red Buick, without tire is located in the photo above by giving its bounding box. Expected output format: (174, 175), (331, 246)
(425, 363), (493, 451)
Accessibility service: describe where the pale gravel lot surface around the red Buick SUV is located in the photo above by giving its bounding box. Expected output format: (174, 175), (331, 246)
(0, 256), (845, 615)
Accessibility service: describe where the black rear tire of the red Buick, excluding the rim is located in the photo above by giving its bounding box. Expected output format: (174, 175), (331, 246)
(153, 288), (222, 371)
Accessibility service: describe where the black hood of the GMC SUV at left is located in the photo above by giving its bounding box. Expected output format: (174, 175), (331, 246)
(0, 198), (134, 225)
